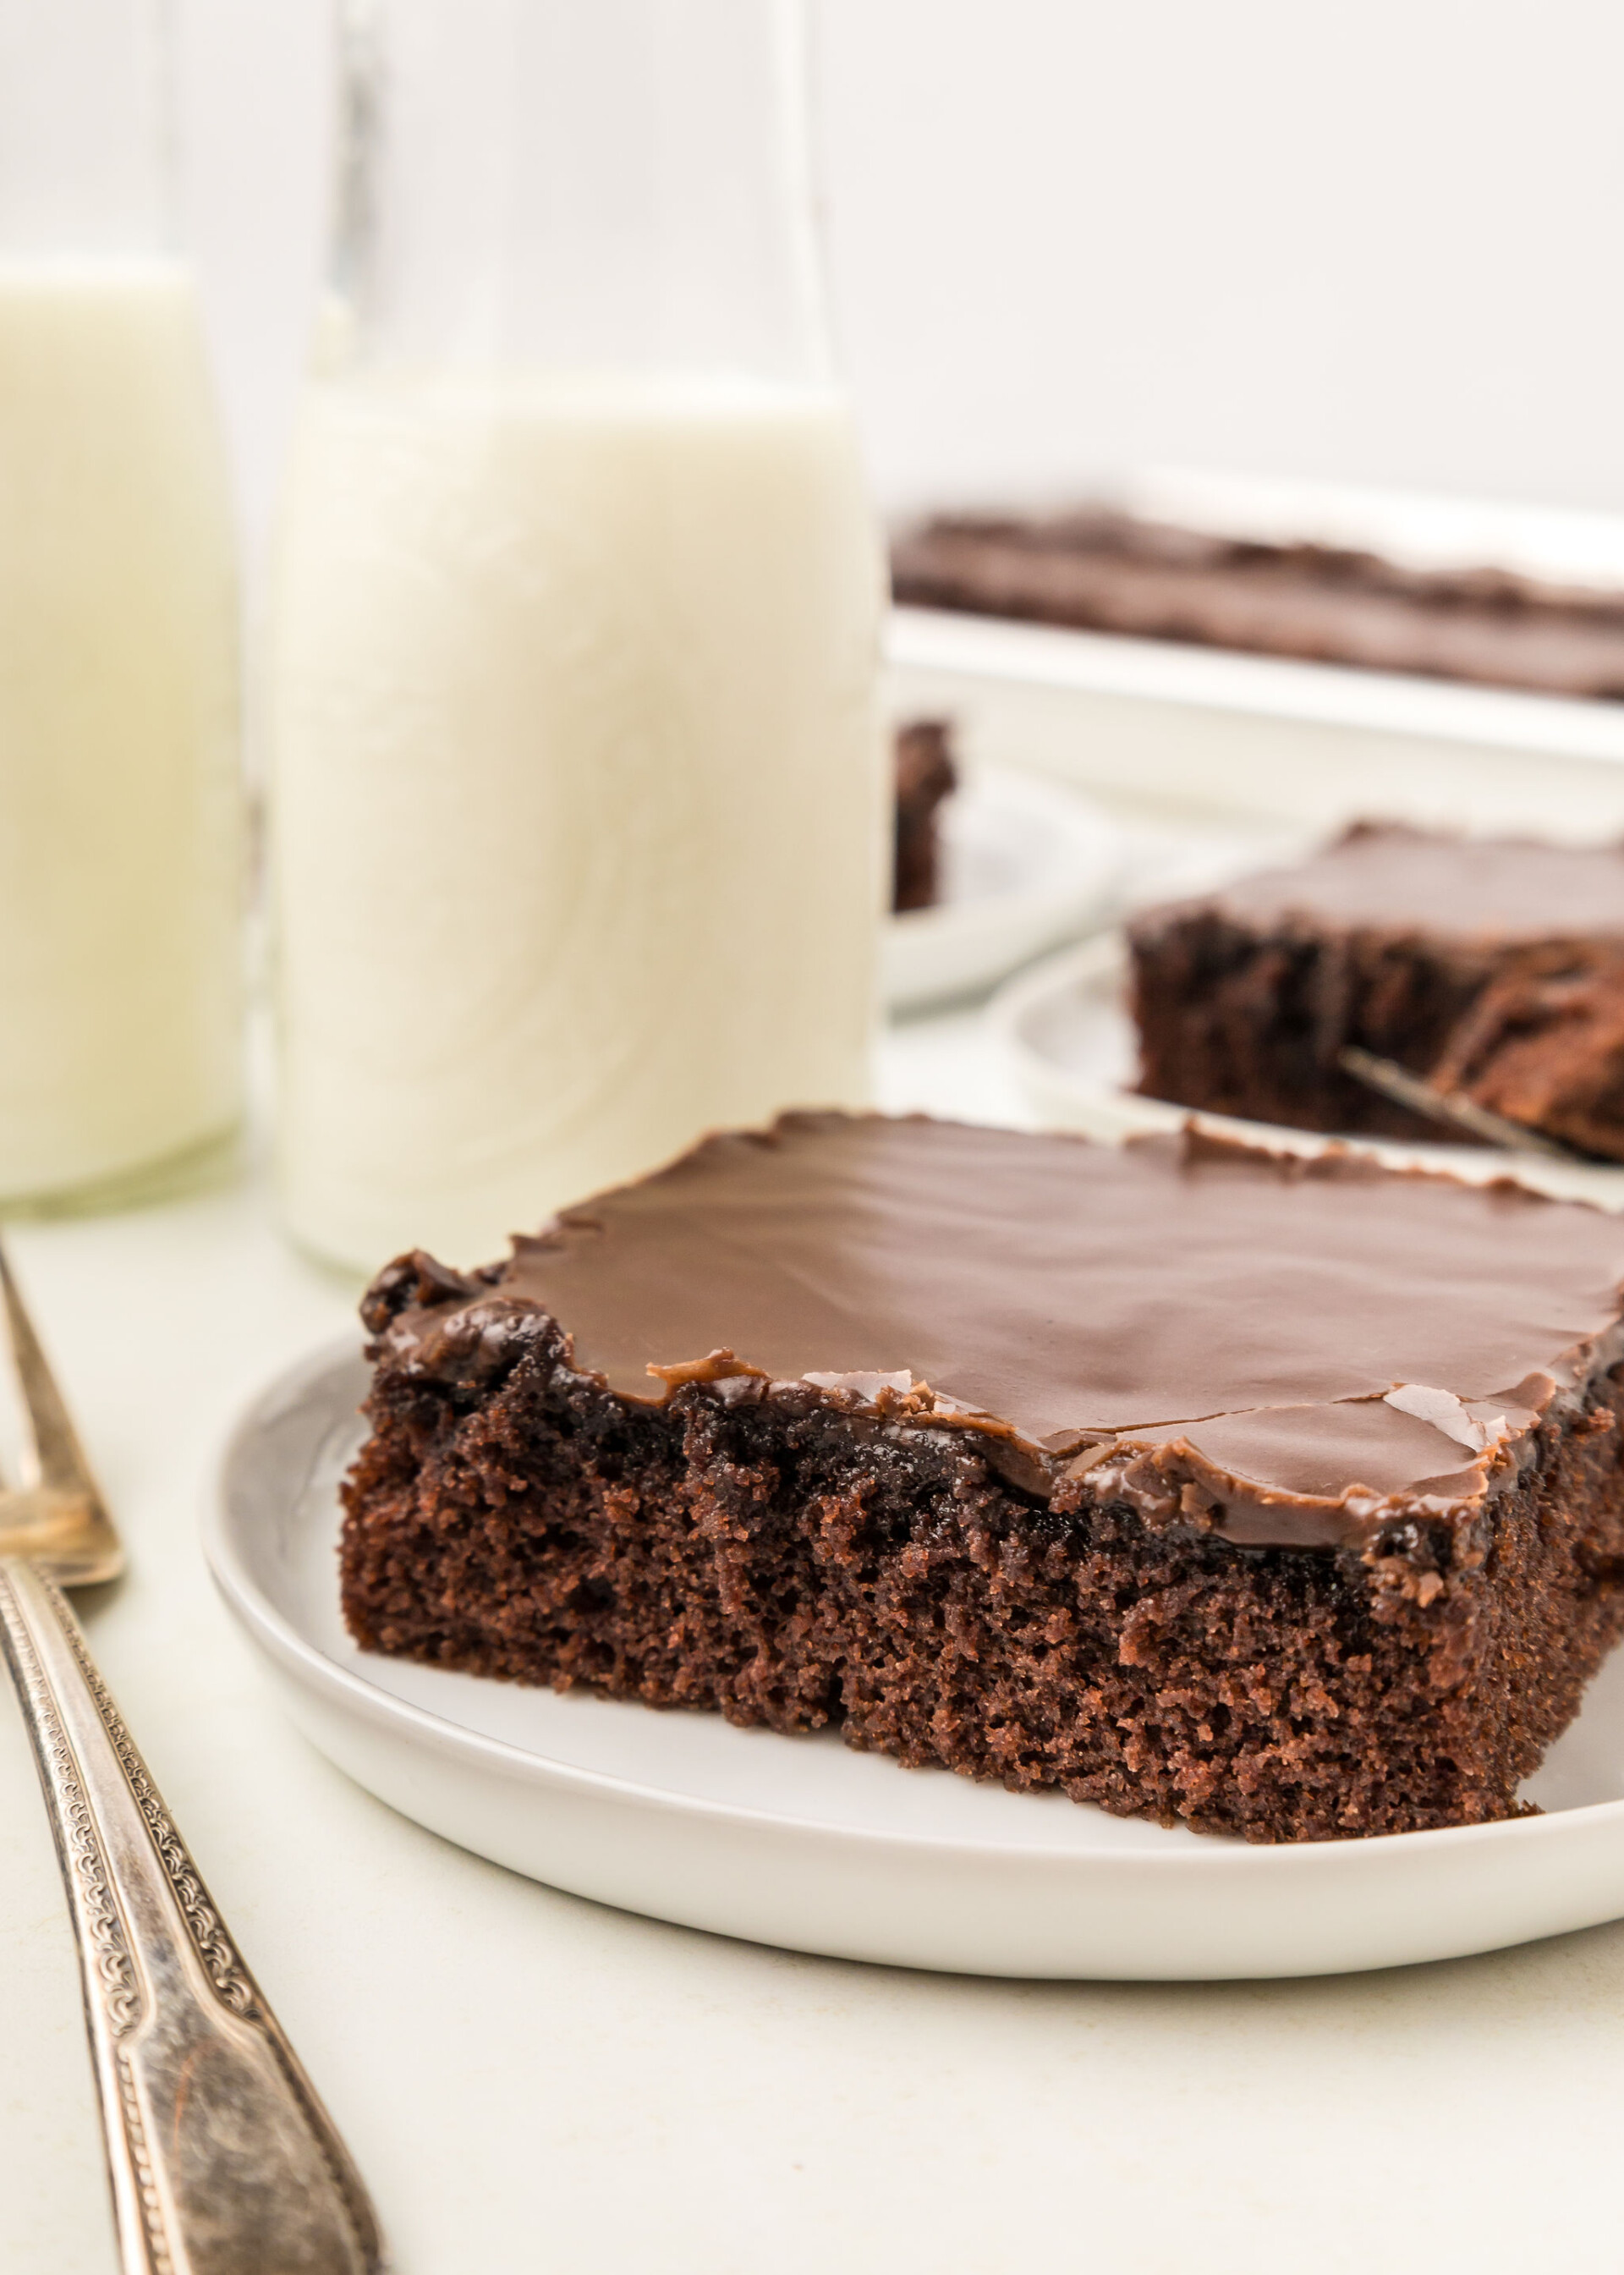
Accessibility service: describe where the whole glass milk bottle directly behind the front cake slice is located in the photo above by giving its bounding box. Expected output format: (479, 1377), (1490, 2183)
(271, 0), (882, 1267)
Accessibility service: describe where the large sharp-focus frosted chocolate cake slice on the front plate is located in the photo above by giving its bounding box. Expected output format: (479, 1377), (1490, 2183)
(343, 1115), (1624, 1840)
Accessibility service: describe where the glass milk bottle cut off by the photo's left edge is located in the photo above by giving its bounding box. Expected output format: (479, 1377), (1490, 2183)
(0, 0), (241, 1206)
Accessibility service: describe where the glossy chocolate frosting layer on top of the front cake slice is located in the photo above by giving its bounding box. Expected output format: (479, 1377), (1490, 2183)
(387, 1115), (1624, 1545)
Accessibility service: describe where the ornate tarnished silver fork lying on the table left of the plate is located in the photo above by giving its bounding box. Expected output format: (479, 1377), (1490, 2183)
(0, 1247), (384, 2275)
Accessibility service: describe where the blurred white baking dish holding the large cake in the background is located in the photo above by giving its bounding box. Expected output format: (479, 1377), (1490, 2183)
(889, 478), (1624, 838)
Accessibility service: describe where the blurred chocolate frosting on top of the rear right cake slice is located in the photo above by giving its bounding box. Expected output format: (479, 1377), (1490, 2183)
(1173, 823), (1624, 944)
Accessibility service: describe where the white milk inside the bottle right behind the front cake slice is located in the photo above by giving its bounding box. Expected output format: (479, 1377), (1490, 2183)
(273, 377), (882, 1267)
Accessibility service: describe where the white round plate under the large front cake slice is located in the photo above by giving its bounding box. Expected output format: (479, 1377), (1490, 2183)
(205, 1347), (1624, 1979)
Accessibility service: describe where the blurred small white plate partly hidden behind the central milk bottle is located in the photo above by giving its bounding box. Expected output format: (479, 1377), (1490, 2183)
(881, 767), (1122, 1010)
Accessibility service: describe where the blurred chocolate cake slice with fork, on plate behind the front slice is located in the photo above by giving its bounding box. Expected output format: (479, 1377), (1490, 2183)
(1128, 822), (1624, 1160)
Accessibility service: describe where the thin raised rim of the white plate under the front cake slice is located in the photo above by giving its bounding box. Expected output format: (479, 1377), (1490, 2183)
(200, 1328), (1624, 1882)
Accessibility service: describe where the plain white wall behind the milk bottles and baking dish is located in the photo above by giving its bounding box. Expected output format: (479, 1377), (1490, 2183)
(179, 0), (1624, 548)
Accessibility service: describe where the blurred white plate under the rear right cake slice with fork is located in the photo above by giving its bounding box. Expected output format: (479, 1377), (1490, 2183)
(987, 932), (1624, 1211)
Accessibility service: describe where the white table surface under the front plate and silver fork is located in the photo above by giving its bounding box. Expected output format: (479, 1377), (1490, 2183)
(0, 1014), (1624, 2275)
